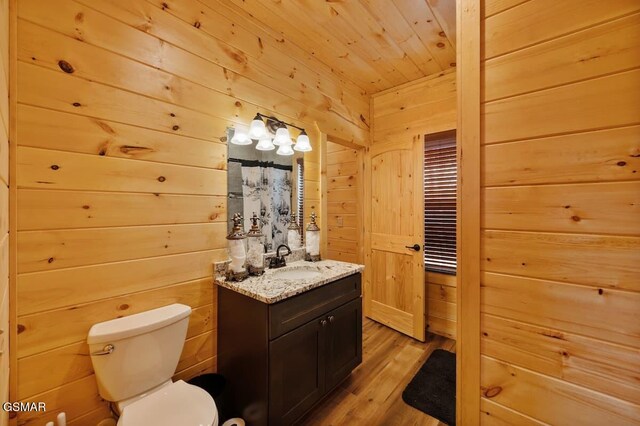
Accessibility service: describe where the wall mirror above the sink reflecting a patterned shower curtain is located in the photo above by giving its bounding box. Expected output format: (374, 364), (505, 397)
(227, 129), (304, 253)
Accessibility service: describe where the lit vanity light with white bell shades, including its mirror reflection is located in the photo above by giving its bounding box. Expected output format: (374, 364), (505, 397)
(231, 113), (312, 155)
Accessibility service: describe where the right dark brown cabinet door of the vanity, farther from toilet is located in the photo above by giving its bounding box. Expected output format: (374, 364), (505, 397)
(325, 298), (362, 390)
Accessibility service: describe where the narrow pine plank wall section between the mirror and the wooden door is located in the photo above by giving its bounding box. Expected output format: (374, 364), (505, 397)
(326, 141), (364, 263)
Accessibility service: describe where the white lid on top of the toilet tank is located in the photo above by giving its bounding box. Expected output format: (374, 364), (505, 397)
(87, 303), (191, 345)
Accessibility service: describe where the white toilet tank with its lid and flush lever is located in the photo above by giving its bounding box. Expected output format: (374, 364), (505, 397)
(87, 303), (191, 401)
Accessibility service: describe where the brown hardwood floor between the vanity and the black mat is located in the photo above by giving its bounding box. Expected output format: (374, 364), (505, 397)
(301, 318), (456, 426)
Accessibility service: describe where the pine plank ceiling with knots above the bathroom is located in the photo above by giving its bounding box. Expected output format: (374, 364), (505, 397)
(232, 0), (456, 94)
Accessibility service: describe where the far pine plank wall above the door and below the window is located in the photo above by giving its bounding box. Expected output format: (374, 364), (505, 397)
(372, 69), (457, 339)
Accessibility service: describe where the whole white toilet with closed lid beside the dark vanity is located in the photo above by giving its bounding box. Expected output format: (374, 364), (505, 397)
(87, 303), (218, 426)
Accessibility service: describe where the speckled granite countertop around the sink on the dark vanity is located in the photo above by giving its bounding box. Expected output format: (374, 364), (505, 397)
(217, 260), (364, 304)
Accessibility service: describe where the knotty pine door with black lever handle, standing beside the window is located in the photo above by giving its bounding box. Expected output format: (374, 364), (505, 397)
(364, 137), (425, 341)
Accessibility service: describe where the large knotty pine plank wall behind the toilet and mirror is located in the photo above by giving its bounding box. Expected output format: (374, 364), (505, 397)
(11, 0), (369, 425)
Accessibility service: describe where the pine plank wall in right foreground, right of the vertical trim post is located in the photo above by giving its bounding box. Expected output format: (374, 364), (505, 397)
(480, 0), (640, 425)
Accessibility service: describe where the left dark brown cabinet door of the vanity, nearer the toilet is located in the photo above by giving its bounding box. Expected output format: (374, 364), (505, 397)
(269, 316), (327, 425)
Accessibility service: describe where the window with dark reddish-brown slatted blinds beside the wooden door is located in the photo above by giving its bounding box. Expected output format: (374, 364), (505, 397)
(424, 130), (457, 275)
